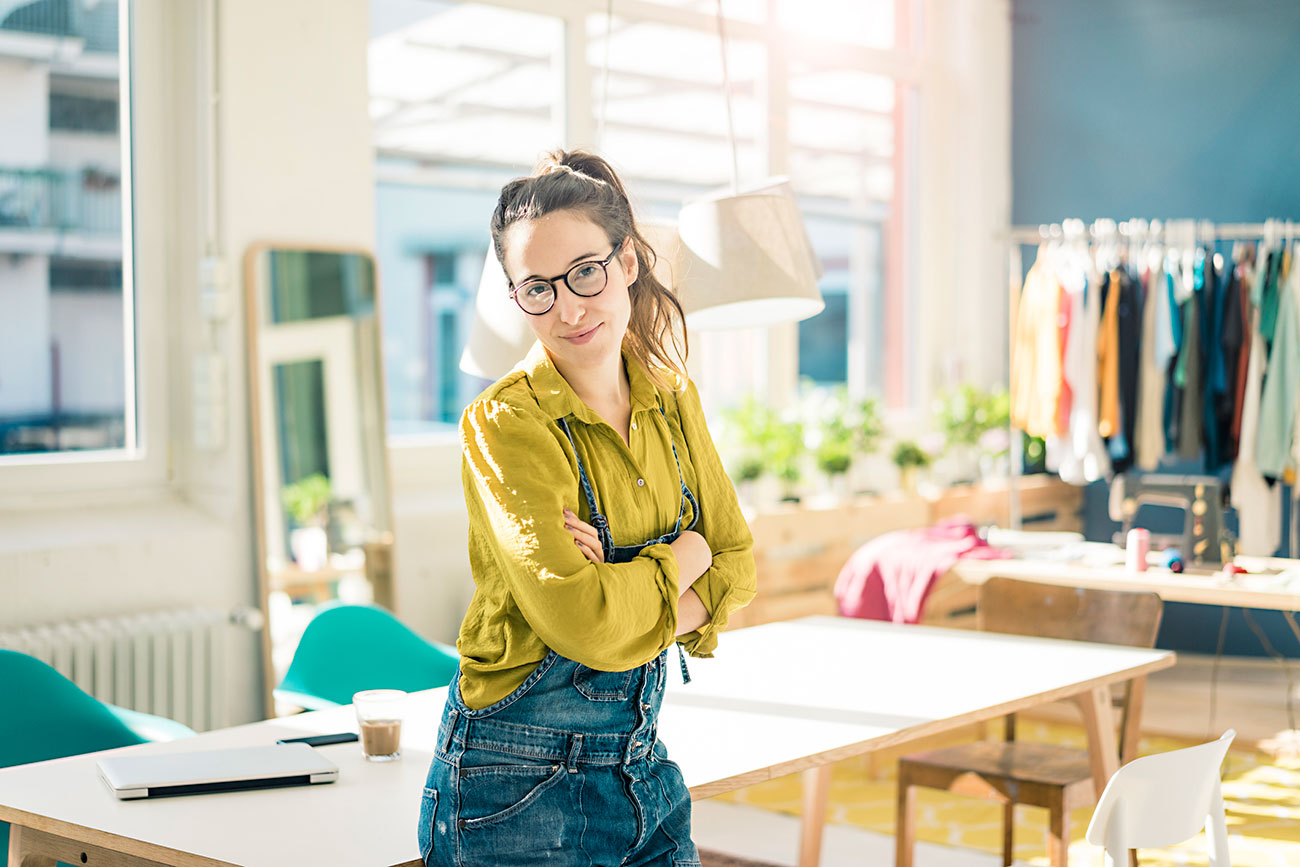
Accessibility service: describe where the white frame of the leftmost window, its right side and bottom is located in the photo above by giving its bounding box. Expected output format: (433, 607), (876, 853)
(0, 0), (172, 510)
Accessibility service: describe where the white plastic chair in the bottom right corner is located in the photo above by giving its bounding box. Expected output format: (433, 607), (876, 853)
(1086, 729), (1236, 867)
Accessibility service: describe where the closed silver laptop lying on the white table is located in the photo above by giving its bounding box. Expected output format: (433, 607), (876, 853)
(99, 744), (338, 801)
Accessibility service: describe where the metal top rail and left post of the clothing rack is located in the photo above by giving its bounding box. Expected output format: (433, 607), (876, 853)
(995, 218), (1300, 532)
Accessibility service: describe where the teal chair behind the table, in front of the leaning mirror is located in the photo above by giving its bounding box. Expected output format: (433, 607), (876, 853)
(276, 604), (460, 711)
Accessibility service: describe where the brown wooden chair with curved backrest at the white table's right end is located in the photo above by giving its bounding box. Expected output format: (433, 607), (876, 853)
(896, 578), (1164, 867)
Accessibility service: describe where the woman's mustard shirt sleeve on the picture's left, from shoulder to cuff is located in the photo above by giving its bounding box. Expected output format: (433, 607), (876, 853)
(460, 399), (681, 671)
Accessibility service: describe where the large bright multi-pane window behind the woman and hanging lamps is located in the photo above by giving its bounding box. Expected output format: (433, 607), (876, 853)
(371, 0), (917, 435)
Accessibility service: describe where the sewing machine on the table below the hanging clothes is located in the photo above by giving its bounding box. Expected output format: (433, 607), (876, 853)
(1110, 473), (1234, 569)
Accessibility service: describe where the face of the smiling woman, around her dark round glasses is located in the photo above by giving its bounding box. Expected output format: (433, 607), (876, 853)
(504, 211), (637, 372)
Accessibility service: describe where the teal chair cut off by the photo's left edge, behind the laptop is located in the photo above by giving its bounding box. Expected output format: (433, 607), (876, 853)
(0, 650), (194, 853)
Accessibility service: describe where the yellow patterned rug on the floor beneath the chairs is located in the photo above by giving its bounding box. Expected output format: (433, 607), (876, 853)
(719, 720), (1300, 867)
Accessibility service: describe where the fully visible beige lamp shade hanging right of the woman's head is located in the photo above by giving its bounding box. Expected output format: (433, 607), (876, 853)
(677, 183), (826, 329)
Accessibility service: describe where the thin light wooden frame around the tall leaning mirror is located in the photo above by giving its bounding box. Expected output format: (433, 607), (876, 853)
(243, 240), (397, 719)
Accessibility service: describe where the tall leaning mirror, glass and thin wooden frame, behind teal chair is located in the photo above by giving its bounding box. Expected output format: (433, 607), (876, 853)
(244, 244), (393, 701)
